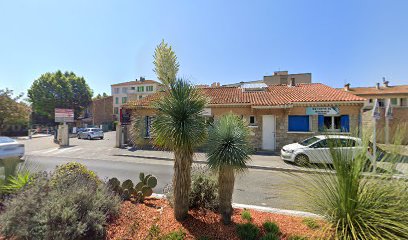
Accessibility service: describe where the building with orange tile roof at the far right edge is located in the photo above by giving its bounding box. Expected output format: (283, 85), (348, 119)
(343, 79), (408, 144)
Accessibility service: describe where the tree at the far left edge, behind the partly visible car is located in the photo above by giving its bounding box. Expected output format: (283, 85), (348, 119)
(0, 88), (30, 135)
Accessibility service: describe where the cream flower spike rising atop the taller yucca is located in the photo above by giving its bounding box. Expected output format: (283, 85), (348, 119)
(153, 40), (180, 87)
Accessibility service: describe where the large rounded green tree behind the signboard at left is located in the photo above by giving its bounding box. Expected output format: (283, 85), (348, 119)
(28, 70), (93, 122)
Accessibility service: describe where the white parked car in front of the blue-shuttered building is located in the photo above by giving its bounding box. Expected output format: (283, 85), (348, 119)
(281, 135), (362, 165)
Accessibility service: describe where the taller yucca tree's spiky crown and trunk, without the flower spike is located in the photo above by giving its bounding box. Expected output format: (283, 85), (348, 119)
(152, 79), (207, 221)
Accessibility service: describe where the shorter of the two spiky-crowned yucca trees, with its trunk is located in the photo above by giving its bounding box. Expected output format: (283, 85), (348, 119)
(207, 114), (252, 224)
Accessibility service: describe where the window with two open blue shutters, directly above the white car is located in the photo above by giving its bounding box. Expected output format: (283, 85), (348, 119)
(318, 115), (350, 132)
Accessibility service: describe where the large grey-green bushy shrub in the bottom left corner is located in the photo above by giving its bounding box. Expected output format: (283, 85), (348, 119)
(0, 164), (120, 239)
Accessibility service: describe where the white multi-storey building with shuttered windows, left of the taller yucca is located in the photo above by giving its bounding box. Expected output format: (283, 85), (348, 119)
(111, 77), (161, 120)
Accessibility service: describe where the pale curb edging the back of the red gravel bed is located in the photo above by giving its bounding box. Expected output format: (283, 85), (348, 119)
(152, 193), (323, 219)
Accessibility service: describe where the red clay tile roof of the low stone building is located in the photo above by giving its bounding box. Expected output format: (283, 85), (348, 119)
(127, 83), (365, 107)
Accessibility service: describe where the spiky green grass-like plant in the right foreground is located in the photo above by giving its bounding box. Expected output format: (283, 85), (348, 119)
(298, 127), (408, 240)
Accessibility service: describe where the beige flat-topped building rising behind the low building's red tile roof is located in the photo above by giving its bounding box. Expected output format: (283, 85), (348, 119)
(223, 71), (312, 87)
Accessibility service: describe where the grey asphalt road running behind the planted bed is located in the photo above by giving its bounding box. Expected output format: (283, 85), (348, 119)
(15, 132), (308, 211)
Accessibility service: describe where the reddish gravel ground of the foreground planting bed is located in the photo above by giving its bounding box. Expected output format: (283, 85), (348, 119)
(107, 198), (324, 240)
